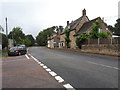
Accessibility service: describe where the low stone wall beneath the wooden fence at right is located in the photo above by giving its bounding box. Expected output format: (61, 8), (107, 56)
(81, 44), (120, 56)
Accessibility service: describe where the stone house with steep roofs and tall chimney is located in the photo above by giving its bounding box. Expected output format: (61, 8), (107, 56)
(47, 9), (110, 49)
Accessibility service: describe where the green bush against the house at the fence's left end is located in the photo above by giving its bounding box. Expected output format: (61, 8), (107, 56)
(76, 34), (89, 48)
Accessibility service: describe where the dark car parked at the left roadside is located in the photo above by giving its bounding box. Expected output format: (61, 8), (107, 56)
(8, 46), (27, 56)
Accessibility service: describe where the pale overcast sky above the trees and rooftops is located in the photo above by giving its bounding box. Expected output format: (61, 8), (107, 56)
(0, 0), (120, 37)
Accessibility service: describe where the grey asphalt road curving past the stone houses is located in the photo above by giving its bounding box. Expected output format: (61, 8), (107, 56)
(29, 47), (119, 88)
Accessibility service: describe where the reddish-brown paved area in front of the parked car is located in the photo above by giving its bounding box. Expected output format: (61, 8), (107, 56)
(2, 55), (65, 90)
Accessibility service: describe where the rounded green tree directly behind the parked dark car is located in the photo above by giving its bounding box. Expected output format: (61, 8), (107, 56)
(8, 27), (25, 45)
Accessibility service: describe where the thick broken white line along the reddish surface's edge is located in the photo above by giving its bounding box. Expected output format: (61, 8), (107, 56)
(28, 54), (75, 90)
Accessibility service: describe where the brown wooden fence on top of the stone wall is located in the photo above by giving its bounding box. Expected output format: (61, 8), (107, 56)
(82, 37), (120, 45)
